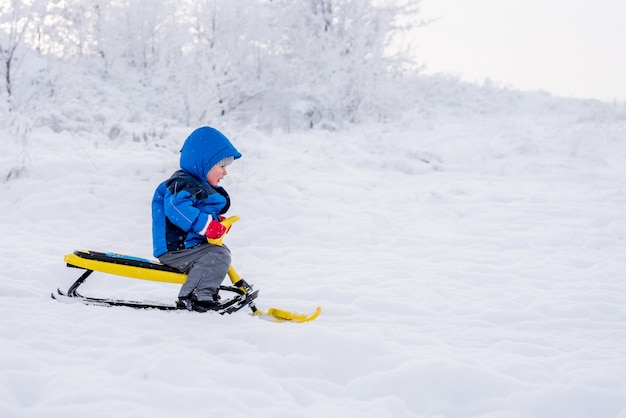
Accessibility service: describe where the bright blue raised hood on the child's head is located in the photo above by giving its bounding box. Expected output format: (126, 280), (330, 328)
(180, 126), (241, 183)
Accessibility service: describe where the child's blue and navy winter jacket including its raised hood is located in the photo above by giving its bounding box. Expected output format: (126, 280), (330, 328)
(152, 126), (241, 257)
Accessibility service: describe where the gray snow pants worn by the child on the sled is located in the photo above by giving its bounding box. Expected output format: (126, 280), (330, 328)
(159, 244), (230, 301)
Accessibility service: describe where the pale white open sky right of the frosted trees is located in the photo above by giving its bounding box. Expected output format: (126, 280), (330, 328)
(416, 0), (626, 101)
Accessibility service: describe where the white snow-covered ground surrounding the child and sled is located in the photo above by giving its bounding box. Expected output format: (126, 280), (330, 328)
(0, 85), (626, 418)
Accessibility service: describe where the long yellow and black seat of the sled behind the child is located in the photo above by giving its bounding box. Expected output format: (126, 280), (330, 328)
(64, 250), (187, 284)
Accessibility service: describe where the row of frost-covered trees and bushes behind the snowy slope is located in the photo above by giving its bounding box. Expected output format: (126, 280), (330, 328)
(0, 0), (420, 129)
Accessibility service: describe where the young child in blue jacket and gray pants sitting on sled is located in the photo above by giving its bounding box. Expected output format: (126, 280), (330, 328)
(152, 126), (241, 312)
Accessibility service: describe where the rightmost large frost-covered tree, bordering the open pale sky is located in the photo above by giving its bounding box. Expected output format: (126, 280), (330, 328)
(241, 0), (419, 127)
